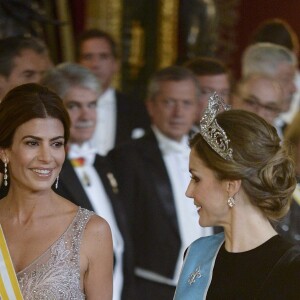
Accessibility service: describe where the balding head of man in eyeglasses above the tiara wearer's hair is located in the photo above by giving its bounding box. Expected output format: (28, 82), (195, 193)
(231, 74), (284, 124)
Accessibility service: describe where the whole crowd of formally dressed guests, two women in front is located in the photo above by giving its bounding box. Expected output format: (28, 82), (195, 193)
(0, 19), (300, 300)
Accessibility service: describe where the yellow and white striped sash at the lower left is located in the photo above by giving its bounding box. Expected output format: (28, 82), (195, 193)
(0, 225), (23, 300)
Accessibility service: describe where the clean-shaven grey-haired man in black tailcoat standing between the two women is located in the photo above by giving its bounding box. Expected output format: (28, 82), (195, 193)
(109, 66), (212, 300)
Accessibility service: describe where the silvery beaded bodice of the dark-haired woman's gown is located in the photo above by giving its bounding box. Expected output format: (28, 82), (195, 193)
(17, 208), (94, 300)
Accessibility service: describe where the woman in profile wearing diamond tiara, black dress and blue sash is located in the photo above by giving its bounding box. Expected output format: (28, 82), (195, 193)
(174, 95), (300, 300)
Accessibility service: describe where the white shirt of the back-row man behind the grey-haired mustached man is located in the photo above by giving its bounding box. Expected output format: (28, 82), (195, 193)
(91, 88), (117, 156)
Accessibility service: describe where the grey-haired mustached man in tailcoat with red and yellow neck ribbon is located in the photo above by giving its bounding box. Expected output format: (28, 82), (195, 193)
(42, 63), (135, 300)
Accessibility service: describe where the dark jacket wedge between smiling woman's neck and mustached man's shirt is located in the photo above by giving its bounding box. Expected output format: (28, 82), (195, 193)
(58, 159), (93, 210)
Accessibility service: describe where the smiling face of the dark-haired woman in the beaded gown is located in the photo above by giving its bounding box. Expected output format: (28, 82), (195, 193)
(3, 118), (65, 191)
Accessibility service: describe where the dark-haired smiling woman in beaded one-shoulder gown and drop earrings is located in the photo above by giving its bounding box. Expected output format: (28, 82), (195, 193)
(0, 84), (113, 300)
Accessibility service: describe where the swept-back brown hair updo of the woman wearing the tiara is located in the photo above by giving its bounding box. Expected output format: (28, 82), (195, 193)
(190, 110), (296, 220)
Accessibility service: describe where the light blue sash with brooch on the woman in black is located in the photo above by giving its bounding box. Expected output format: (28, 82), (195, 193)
(174, 232), (224, 300)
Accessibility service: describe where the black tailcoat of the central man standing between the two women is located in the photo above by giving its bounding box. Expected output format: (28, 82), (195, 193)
(108, 131), (181, 278)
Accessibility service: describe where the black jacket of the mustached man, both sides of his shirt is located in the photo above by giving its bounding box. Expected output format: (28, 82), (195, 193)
(54, 155), (135, 300)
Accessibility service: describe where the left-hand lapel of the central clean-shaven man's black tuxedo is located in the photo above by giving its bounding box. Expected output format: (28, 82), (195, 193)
(140, 131), (179, 233)
